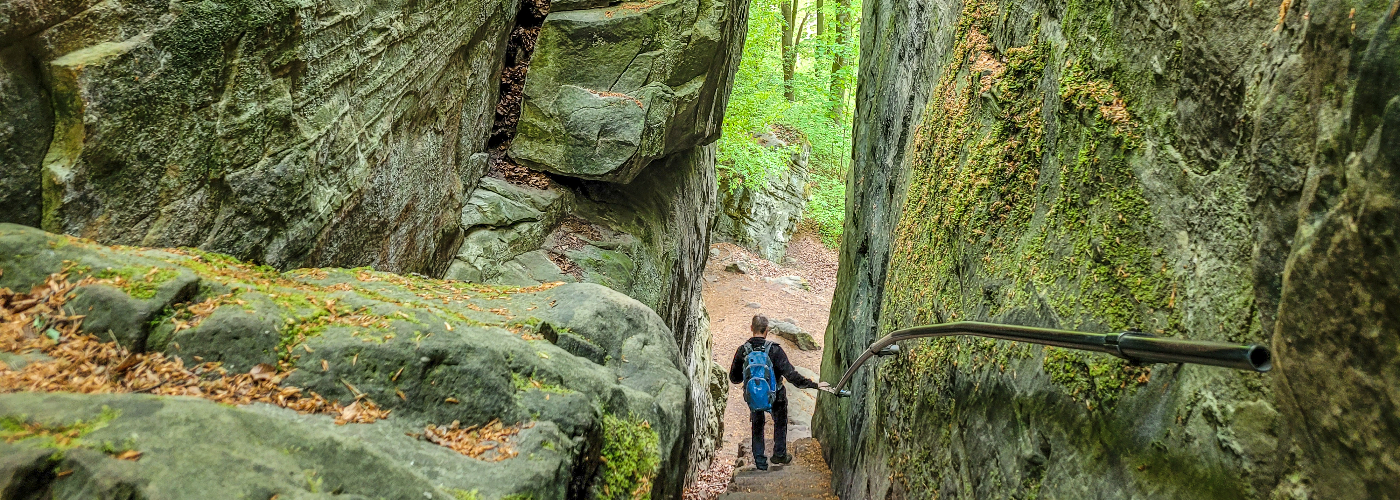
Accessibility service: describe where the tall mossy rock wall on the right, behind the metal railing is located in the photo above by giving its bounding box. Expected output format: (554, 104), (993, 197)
(815, 0), (1400, 499)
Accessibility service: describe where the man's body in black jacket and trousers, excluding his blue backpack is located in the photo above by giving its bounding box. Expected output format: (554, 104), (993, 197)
(729, 314), (826, 471)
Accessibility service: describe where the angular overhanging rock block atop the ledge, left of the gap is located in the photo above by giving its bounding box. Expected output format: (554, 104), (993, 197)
(510, 0), (748, 183)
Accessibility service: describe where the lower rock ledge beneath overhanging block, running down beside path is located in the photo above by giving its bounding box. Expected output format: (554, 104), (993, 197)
(447, 144), (722, 497)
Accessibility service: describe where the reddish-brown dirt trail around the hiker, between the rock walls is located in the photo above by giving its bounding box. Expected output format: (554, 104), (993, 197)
(686, 232), (837, 500)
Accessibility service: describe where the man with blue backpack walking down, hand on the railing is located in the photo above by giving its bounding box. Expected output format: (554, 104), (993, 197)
(729, 314), (827, 471)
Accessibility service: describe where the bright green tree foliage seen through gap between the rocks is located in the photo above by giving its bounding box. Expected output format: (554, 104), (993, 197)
(717, 0), (861, 246)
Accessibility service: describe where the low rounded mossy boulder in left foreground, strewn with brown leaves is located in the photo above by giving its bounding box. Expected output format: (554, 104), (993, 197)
(0, 224), (683, 499)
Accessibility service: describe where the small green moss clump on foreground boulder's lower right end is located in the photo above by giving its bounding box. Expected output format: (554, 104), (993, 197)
(595, 415), (661, 499)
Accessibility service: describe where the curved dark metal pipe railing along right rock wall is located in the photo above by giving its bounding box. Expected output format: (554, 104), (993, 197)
(830, 321), (1273, 398)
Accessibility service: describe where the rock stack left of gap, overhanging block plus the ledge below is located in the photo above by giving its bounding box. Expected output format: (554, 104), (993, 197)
(447, 0), (749, 497)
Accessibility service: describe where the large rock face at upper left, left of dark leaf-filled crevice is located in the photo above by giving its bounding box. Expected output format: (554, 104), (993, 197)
(0, 0), (517, 273)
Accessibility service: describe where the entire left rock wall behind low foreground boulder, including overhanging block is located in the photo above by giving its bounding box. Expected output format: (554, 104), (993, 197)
(0, 0), (749, 497)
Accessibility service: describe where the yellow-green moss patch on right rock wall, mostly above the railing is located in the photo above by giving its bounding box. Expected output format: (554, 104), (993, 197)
(881, 3), (1180, 408)
